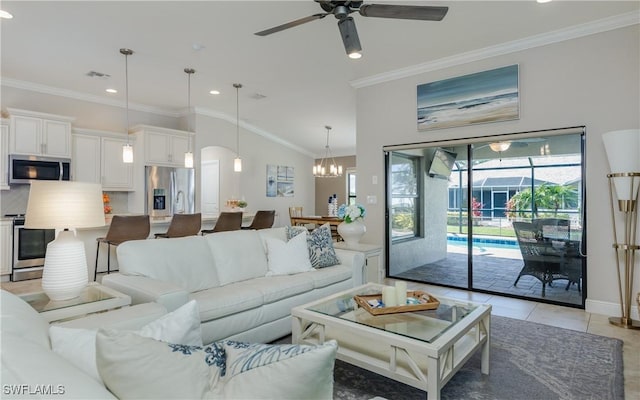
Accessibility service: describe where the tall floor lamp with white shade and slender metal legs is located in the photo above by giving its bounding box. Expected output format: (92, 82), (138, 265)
(602, 129), (640, 329)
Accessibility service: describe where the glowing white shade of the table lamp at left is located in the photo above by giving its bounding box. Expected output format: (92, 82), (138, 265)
(25, 181), (104, 229)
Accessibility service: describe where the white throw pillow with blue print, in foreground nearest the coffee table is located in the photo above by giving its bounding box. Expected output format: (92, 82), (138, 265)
(213, 340), (338, 399)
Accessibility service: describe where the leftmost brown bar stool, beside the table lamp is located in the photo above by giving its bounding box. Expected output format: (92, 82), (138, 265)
(93, 215), (151, 281)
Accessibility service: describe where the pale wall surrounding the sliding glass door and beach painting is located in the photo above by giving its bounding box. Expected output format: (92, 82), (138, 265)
(356, 25), (640, 315)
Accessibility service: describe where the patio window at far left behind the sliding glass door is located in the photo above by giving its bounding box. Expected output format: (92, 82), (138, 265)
(390, 153), (421, 240)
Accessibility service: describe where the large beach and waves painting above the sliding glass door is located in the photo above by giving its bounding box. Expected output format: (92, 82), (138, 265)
(418, 64), (520, 130)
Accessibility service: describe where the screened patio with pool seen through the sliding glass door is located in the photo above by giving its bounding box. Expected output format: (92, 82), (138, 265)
(385, 127), (586, 308)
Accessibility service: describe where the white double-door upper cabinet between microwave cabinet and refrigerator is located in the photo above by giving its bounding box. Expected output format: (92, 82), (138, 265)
(71, 129), (134, 191)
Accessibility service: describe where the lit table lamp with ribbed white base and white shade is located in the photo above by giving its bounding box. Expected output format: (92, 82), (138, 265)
(25, 181), (104, 301)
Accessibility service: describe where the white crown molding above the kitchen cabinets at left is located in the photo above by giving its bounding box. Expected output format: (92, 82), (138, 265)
(2, 77), (180, 118)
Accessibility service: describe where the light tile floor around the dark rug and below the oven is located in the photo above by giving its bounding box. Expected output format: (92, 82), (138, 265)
(1, 279), (640, 399)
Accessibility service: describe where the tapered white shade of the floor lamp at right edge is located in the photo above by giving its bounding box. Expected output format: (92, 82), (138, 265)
(602, 129), (640, 200)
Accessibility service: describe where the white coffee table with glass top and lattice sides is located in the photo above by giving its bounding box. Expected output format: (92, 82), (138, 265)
(291, 283), (491, 399)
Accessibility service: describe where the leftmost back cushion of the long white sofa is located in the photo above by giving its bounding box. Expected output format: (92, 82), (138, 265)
(117, 236), (220, 292)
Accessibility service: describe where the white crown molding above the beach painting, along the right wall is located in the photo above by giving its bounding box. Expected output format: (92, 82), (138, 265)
(349, 11), (640, 89)
